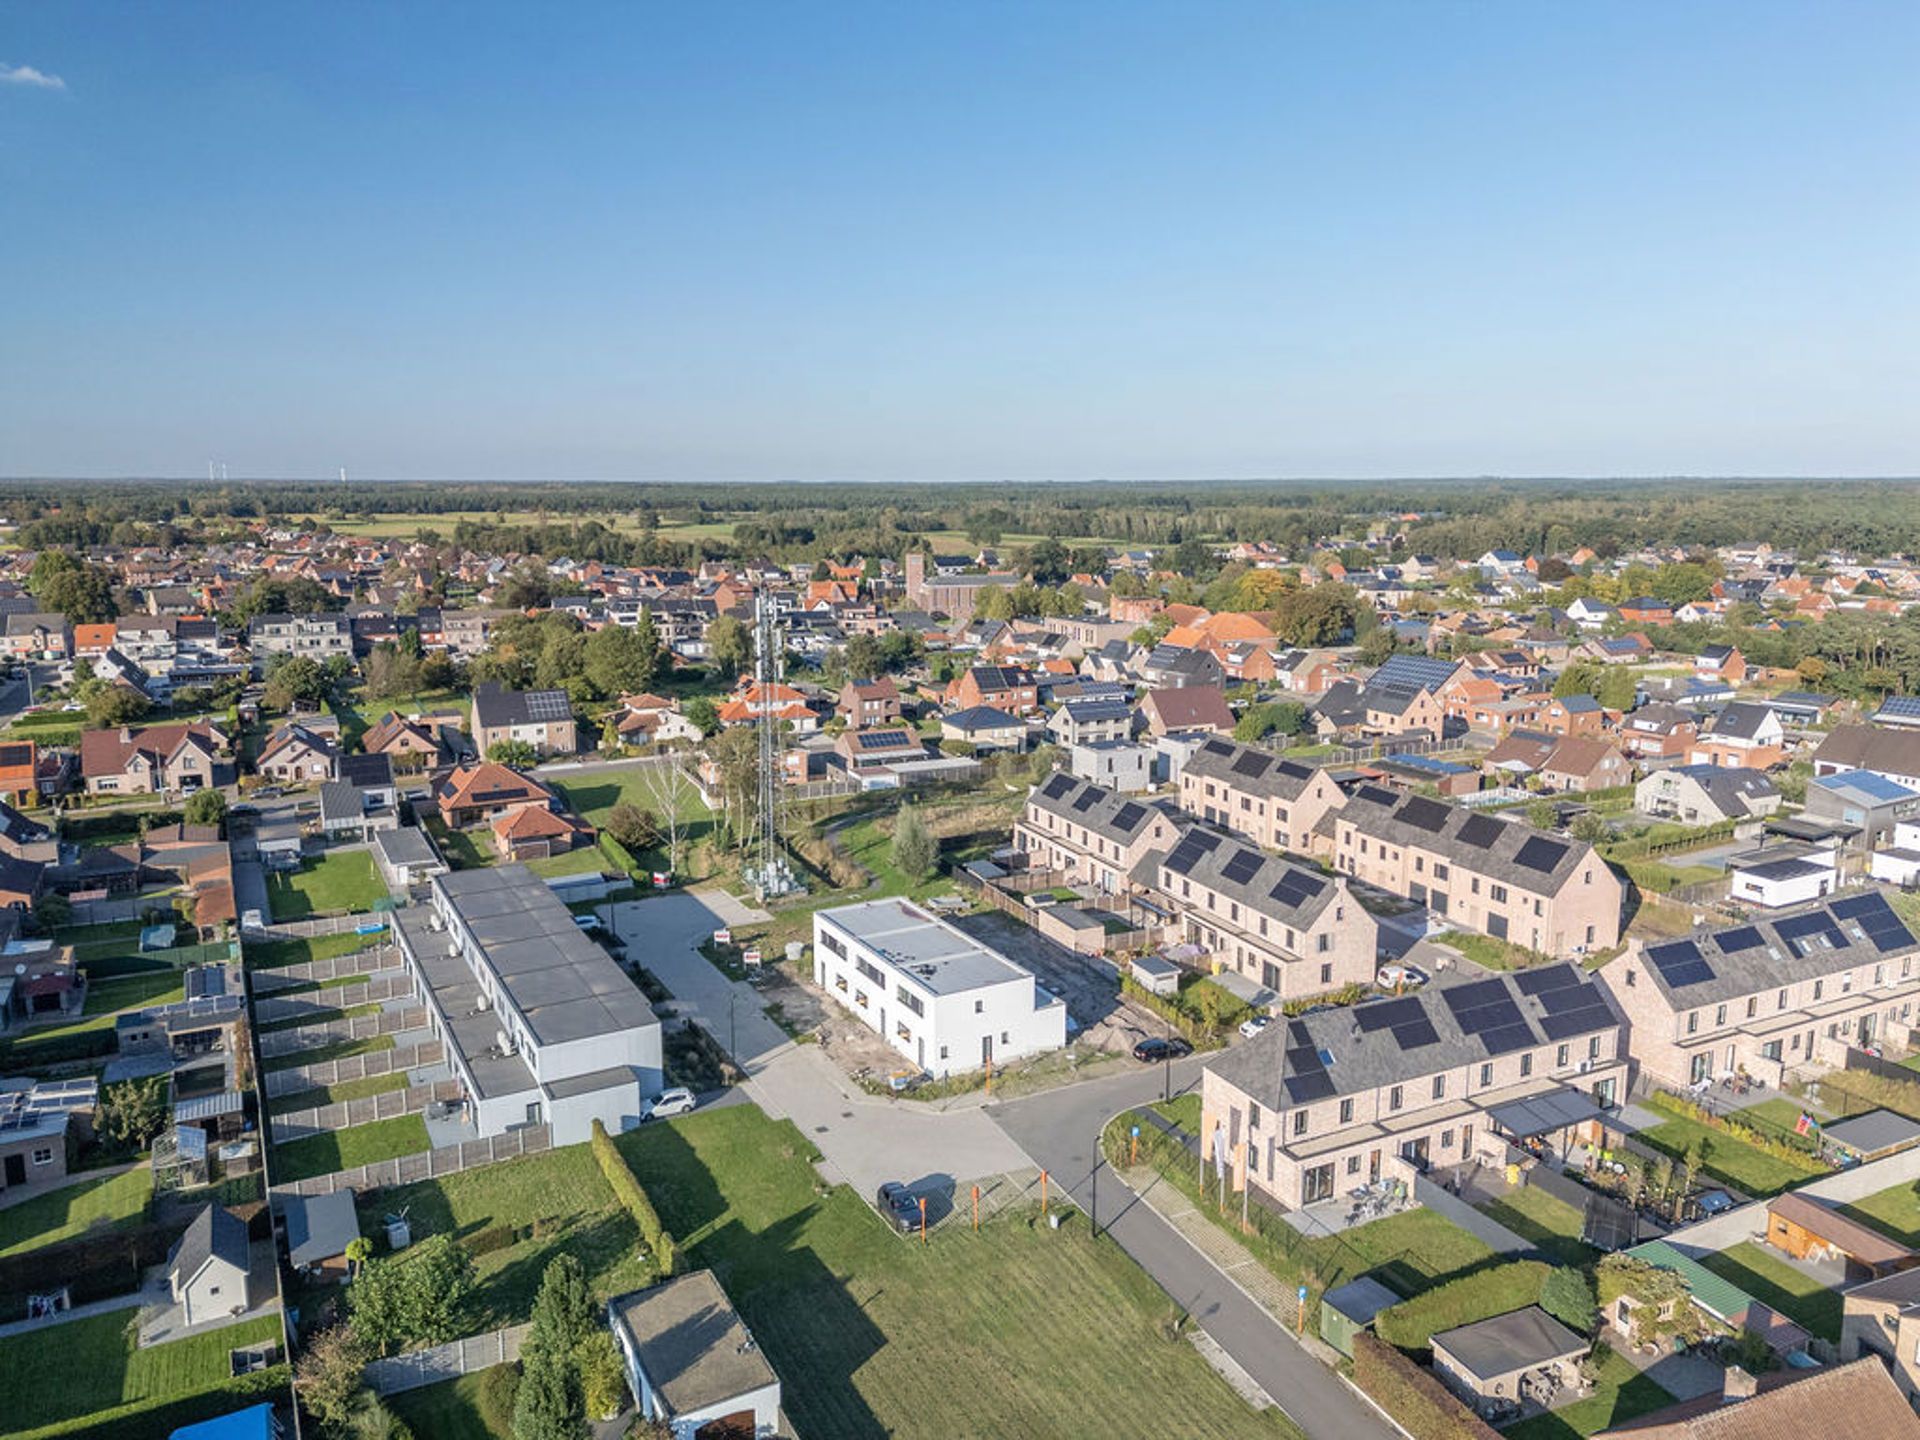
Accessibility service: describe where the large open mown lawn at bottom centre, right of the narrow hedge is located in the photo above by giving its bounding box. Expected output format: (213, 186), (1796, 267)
(618, 1106), (1298, 1440)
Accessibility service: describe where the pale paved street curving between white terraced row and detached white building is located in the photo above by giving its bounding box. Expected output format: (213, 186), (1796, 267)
(601, 891), (1031, 1194)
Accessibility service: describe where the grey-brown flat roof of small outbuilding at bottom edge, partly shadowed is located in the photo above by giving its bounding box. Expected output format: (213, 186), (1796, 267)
(609, 1269), (780, 1415)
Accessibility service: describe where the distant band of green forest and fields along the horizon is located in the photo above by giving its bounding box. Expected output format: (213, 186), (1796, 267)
(0, 480), (1920, 563)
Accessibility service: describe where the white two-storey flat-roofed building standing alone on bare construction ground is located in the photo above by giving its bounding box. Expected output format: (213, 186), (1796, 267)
(814, 900), (1068, 1075)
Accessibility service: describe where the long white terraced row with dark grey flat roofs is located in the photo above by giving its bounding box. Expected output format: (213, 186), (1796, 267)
(394, 864), (662, 1144)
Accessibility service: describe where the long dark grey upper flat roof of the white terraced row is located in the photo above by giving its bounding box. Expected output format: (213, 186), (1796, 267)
(434, 864), (659, 1044)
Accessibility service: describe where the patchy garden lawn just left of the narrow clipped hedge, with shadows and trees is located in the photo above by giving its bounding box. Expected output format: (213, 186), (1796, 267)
(351, 1144), (653, 1328)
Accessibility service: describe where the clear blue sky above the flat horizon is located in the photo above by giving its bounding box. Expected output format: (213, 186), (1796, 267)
(0, 0), (1920, 480)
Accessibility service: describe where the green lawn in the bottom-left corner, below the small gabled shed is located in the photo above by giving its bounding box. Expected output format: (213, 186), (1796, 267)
(0, 1309), (280, 1430)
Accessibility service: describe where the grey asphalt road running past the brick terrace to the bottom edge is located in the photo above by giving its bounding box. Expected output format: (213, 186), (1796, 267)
(987, 1056), (1404, 1440)
